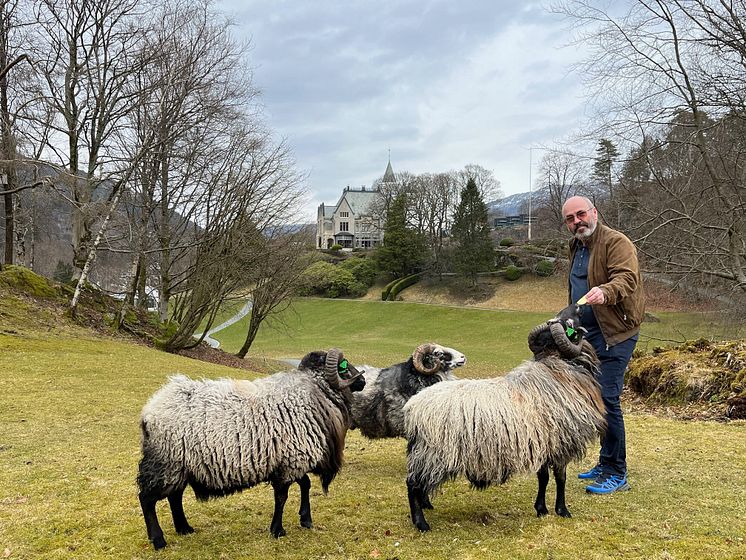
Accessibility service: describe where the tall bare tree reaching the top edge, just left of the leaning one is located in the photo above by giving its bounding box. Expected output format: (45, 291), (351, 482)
(109, 0), (256, 321)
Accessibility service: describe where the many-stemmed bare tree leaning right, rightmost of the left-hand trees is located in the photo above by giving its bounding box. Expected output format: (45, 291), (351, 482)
(161, 126), (304, 350)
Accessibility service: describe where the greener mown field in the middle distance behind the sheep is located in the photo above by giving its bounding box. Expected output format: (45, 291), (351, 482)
(208, 298), (746, 377)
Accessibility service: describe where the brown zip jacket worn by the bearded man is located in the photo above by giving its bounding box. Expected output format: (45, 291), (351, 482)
(568, 222), (645, 346)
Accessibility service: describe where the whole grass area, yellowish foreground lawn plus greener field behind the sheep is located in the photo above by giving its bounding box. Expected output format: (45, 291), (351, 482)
(0, 298), (746, 560)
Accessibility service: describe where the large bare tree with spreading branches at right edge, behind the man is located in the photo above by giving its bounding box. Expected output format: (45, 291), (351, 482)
(563, 0), (746, 295)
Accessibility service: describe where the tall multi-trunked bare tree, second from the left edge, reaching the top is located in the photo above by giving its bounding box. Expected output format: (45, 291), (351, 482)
(30, 0), (145, 270)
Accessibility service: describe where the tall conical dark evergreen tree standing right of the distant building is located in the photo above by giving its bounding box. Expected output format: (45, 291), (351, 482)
(452, 179), (495, 286)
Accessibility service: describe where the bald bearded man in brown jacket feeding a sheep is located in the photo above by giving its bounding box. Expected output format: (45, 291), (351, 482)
(562, 196), (645, 494)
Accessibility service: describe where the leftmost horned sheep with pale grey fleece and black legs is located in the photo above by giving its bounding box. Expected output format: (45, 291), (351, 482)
(137, 349), (365, 549)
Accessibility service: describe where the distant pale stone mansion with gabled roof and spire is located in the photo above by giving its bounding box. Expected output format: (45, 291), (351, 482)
(316, 161), (396, 249)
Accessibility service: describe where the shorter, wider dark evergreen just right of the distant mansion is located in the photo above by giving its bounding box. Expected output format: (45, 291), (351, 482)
(376, 192), (427, 277)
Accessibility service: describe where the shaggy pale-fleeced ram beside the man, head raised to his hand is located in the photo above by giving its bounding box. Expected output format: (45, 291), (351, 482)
(404, 308), (606, 531)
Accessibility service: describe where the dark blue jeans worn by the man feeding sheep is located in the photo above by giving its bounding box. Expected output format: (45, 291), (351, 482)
(586, 330), (637, 476)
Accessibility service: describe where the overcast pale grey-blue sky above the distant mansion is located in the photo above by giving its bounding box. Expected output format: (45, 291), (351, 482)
(219, 0), (584, 220)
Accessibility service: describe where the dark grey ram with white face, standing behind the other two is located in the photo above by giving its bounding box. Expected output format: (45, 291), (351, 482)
(351, 342), (466, 439)
